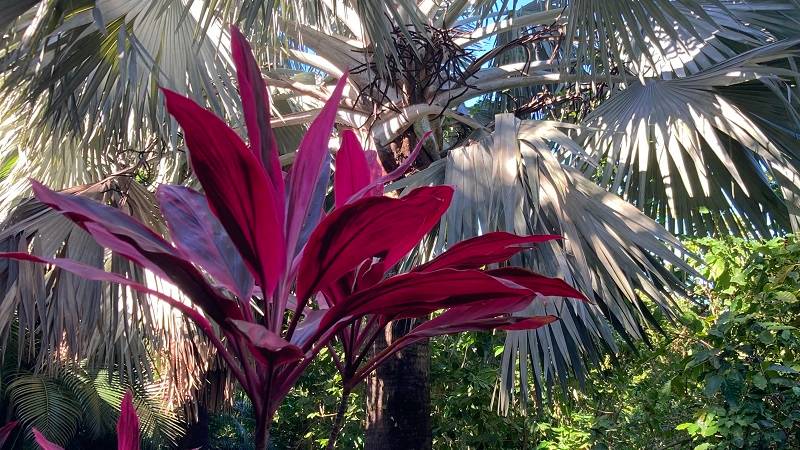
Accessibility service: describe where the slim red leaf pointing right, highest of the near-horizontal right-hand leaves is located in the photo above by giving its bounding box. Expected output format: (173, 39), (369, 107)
(414, 231), (561, 272)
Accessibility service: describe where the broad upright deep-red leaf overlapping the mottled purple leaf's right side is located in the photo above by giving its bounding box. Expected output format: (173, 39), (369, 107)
(163, 89), (286, 296)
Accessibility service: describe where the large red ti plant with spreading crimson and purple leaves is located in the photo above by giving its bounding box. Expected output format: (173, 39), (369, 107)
(0, 28), (582, 449)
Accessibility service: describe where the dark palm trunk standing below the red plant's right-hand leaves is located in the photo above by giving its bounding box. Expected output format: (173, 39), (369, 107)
(365, 326), (433, 450)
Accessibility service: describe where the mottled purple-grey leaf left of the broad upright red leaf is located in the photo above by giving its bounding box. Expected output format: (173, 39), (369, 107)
(156, 184), (253, 300)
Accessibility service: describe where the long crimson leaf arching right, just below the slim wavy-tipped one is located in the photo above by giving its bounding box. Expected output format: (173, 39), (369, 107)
(320, 269), (531, 330)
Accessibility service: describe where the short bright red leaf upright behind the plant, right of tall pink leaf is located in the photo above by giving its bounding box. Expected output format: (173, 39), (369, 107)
(333, 130), (371, 208)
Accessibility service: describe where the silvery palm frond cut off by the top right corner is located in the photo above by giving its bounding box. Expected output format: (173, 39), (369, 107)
(562, 0), (800, 78)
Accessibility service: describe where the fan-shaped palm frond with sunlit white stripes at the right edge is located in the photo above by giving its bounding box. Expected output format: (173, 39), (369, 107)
(580, 39), (800, 236)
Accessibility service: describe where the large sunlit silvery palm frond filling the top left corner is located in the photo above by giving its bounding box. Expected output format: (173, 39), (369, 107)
(0, 0), (234, 197)
